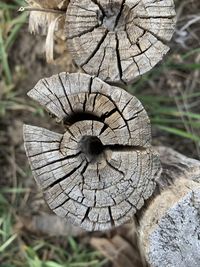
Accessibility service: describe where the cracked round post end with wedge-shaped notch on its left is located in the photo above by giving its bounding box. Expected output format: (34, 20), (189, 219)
(24, 73), (161, 231)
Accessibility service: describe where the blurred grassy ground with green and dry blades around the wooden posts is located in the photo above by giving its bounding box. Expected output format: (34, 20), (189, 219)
(0, 0), (200, 267)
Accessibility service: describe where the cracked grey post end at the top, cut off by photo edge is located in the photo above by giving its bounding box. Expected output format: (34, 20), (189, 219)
(66, 0), (176, 84)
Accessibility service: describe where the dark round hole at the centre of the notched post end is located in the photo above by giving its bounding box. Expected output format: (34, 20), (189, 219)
(80, 136), (104, 160)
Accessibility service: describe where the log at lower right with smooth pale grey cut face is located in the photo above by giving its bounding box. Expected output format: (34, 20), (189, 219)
(139, 147), (200, 267)
